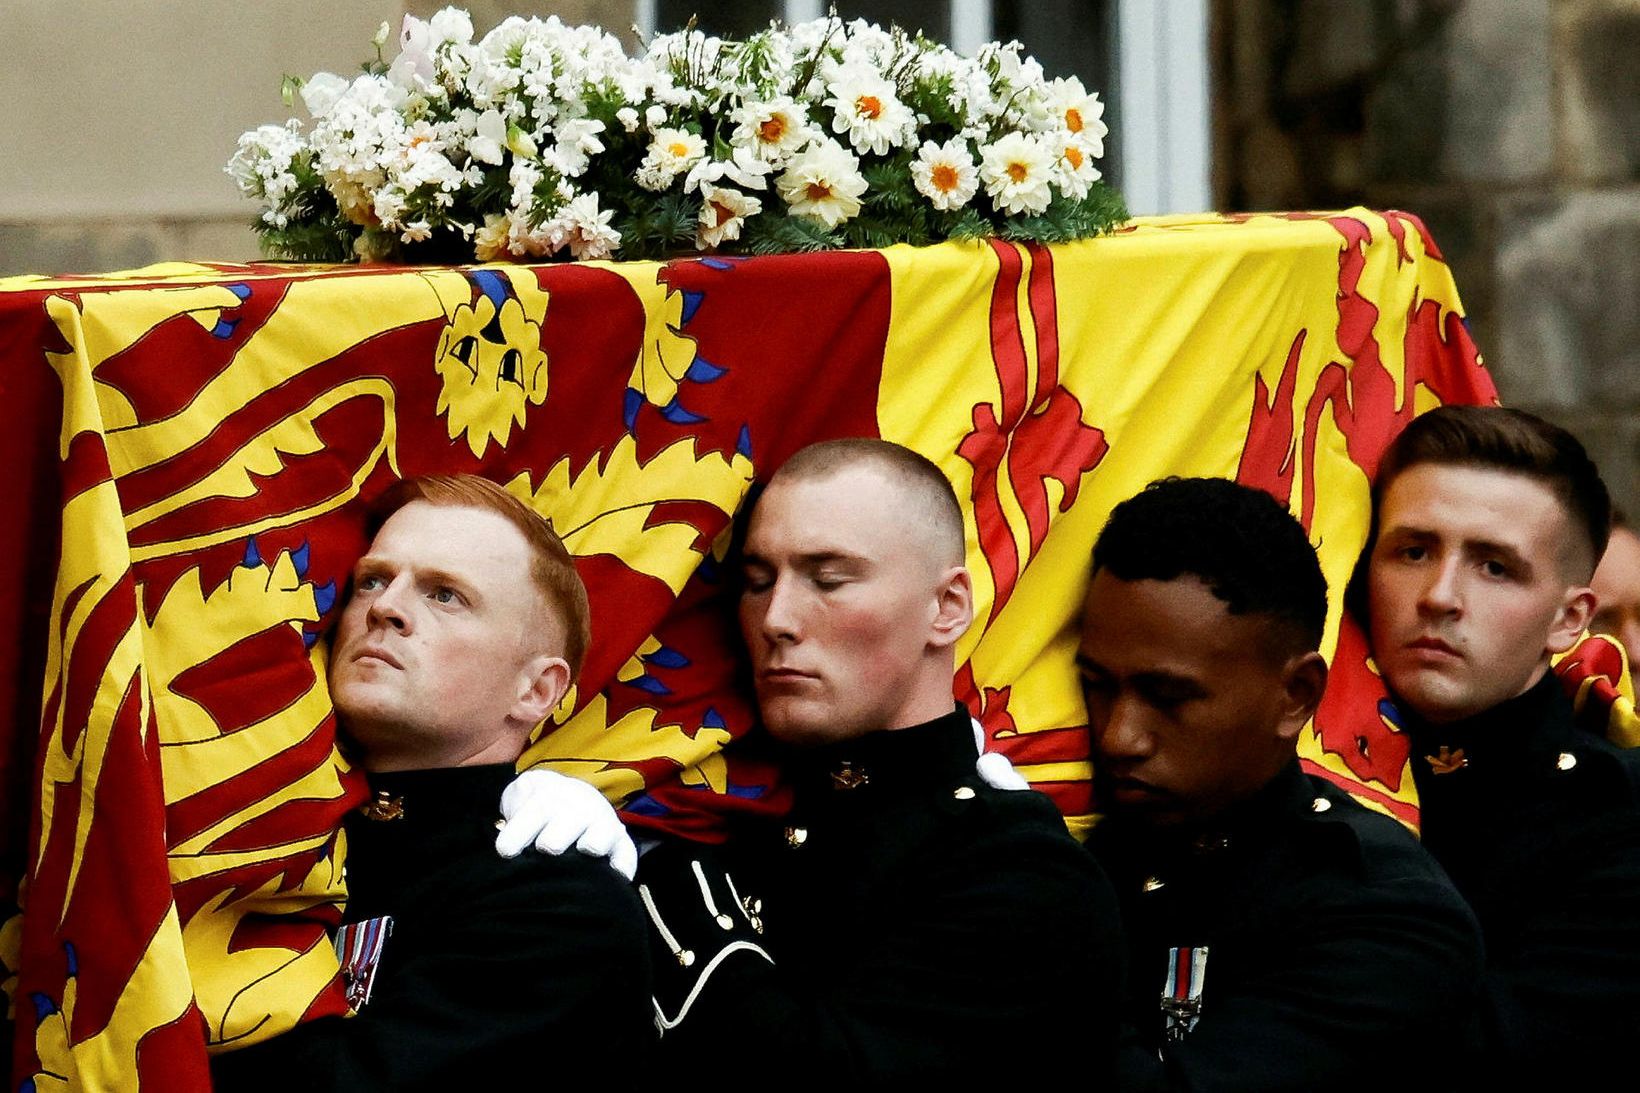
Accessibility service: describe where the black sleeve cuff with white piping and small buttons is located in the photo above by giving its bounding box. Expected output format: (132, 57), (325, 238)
(638, 842), (774, 1034)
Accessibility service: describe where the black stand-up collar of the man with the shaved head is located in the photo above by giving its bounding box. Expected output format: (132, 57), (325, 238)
(789, 706), (979, 803)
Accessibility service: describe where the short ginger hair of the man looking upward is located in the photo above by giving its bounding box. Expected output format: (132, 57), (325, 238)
(364, 474), (592, 679)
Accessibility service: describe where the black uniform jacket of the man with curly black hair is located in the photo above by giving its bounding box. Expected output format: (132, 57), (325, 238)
(1089, 761), (1481, 1093)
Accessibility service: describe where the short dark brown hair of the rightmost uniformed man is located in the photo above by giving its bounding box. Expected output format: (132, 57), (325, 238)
(1369, 405), (1612, 578)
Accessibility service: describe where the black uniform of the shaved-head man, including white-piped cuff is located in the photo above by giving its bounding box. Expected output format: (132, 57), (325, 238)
(638, 707), (1122, 1088)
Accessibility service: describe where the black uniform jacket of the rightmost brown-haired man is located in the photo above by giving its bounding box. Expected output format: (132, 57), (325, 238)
(1405, 673), (1640, 1088)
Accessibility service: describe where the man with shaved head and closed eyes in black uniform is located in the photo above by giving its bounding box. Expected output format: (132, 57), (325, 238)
(638, 440), (1120, 1088)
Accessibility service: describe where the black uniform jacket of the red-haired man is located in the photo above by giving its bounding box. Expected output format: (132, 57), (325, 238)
(212, 765), (656, 1093)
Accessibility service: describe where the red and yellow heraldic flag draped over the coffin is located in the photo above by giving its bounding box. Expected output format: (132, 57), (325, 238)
(0, 210), (1633, 1090)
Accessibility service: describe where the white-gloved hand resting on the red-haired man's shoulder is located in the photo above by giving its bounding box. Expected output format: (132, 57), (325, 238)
(495, 768), (638, 880)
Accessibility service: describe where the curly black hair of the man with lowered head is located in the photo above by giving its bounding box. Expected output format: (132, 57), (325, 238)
(1094, 478), (1327, 652)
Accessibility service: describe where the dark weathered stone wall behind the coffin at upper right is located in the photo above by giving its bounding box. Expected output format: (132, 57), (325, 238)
(1214, 0), (1640, 517)
